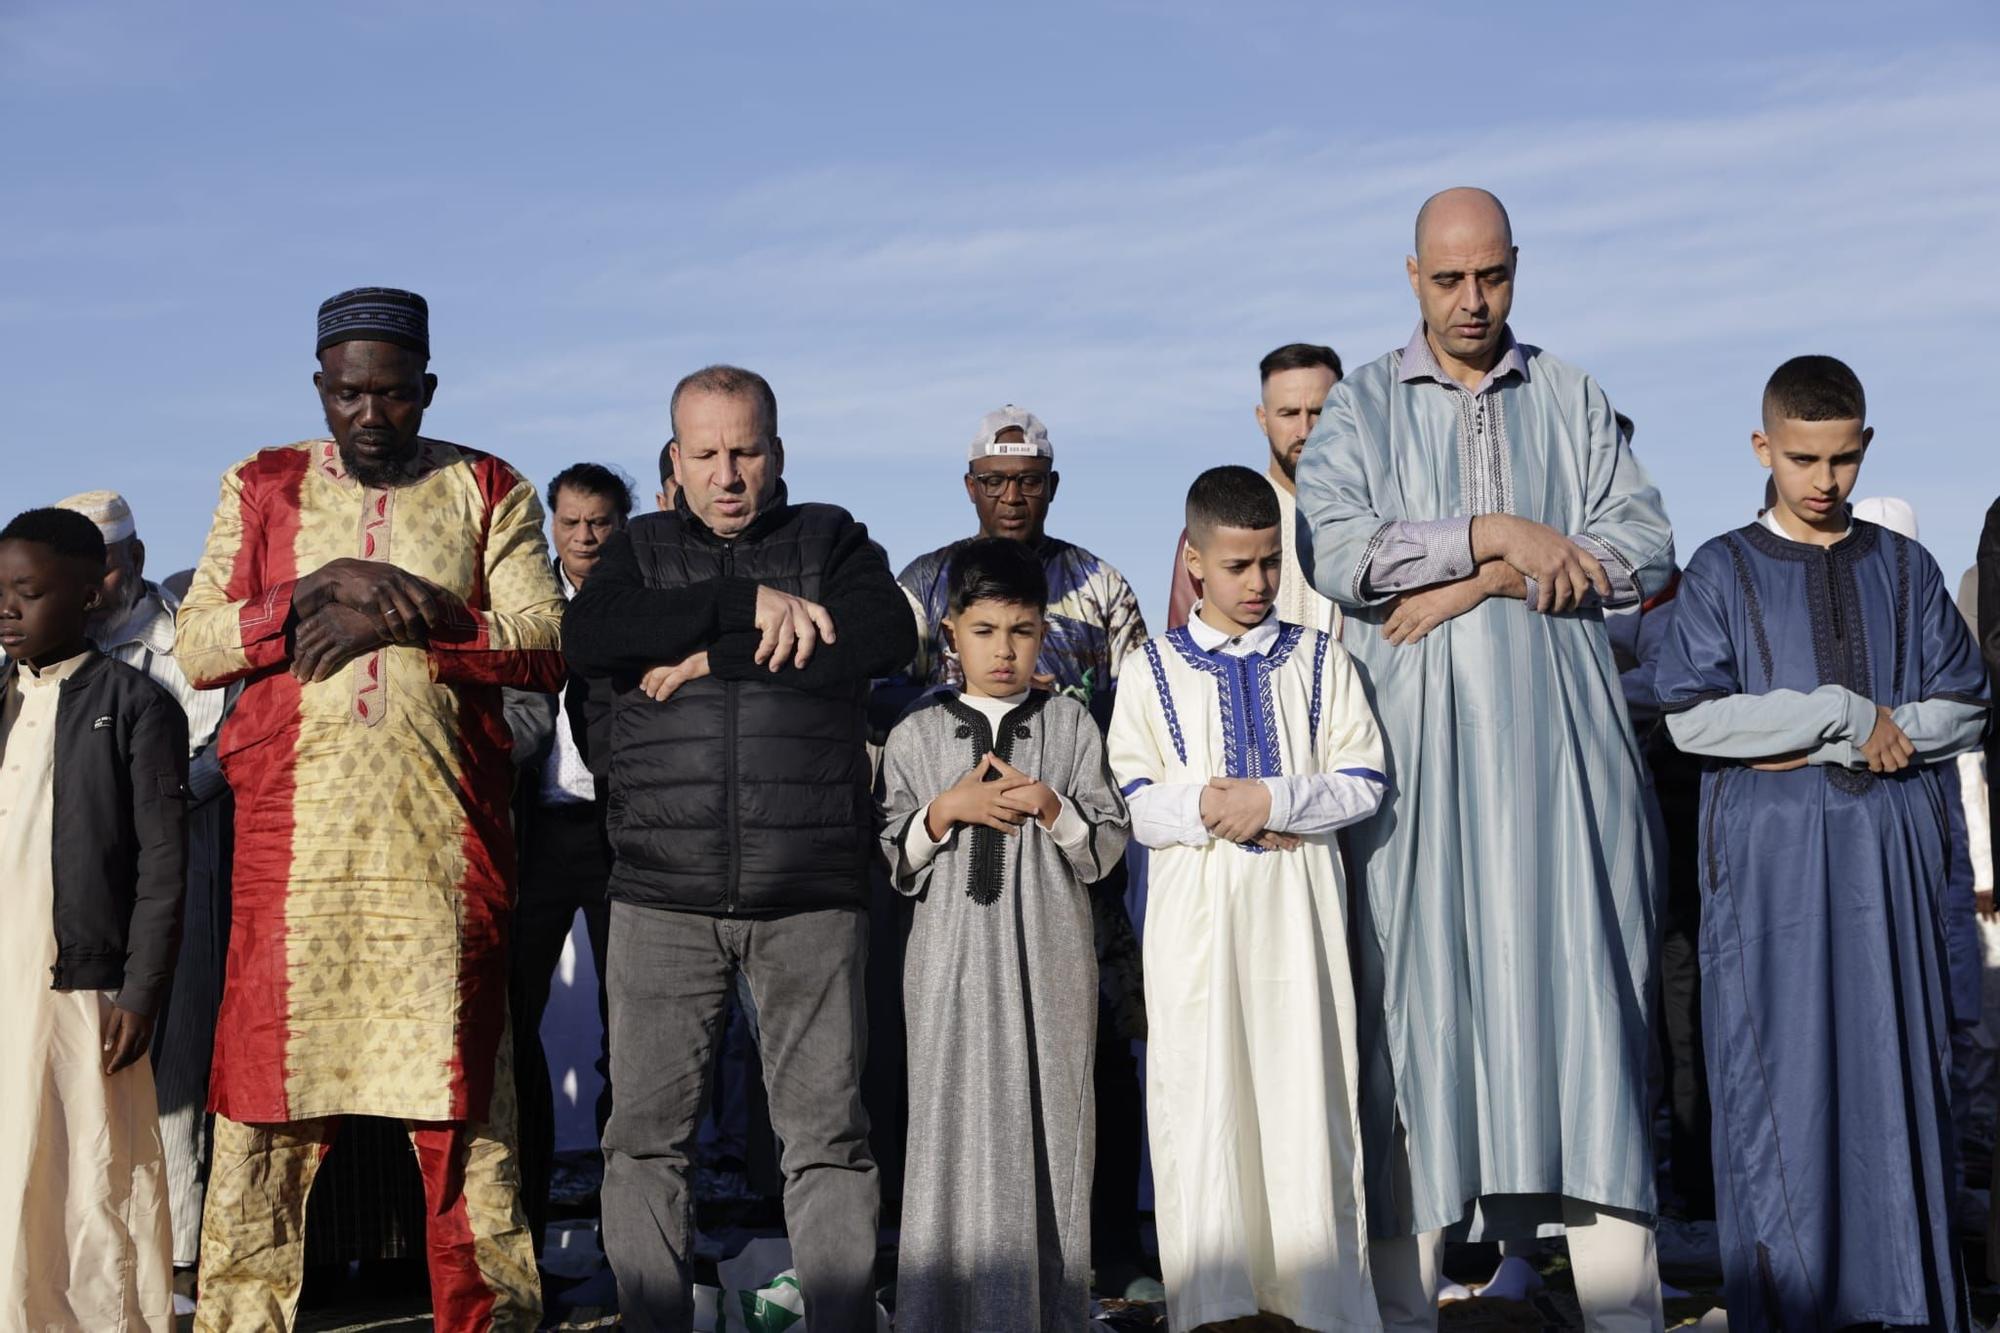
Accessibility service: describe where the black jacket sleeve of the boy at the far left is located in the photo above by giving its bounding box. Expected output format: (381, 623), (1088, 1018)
(116, 691), (188, 1015)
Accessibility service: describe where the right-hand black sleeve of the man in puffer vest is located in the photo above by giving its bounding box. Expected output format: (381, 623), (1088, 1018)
(708, 520), (916, 695)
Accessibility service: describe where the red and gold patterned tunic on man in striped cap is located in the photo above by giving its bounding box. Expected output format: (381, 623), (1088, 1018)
(176, 440), (564, 1123)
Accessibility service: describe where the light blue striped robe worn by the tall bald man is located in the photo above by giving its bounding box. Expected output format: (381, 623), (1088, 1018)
(1298, 332), (1672, 1237)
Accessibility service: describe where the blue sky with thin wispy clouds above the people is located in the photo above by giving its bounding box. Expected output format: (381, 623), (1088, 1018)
(0, 0), (2000, 618)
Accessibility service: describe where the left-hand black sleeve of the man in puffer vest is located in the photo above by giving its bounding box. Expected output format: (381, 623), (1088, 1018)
(562, 532), (756, 679)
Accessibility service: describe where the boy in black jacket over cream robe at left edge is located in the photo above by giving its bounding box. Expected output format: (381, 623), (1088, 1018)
(0, 508), (188, 1333)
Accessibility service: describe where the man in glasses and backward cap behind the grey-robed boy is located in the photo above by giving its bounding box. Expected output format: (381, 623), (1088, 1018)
(884, 404), (1158, 1295)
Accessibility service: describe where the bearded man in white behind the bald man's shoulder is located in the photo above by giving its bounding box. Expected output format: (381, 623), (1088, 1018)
(1166, 342), (1340, 638)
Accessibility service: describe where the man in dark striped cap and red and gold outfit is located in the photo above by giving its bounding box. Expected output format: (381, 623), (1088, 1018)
(178, 288), (562, 1333)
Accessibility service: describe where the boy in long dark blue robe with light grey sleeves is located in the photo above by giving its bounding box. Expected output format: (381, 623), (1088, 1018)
(1656, 356), (1988, 1329)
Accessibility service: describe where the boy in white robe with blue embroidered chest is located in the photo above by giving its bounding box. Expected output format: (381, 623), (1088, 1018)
(1110, 466), (1386, 1329)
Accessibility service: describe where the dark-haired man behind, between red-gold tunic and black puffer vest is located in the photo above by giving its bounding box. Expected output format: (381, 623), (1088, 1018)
(508, 462), (632, 1255)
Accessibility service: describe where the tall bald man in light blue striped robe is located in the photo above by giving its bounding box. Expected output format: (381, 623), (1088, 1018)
(1298, 190), (1674, 1329)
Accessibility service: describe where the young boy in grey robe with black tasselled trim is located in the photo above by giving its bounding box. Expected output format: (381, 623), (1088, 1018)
(882, 538), (1136, 1333)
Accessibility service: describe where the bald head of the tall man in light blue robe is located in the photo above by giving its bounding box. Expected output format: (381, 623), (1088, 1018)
(1404, 186), (1516, 378)
